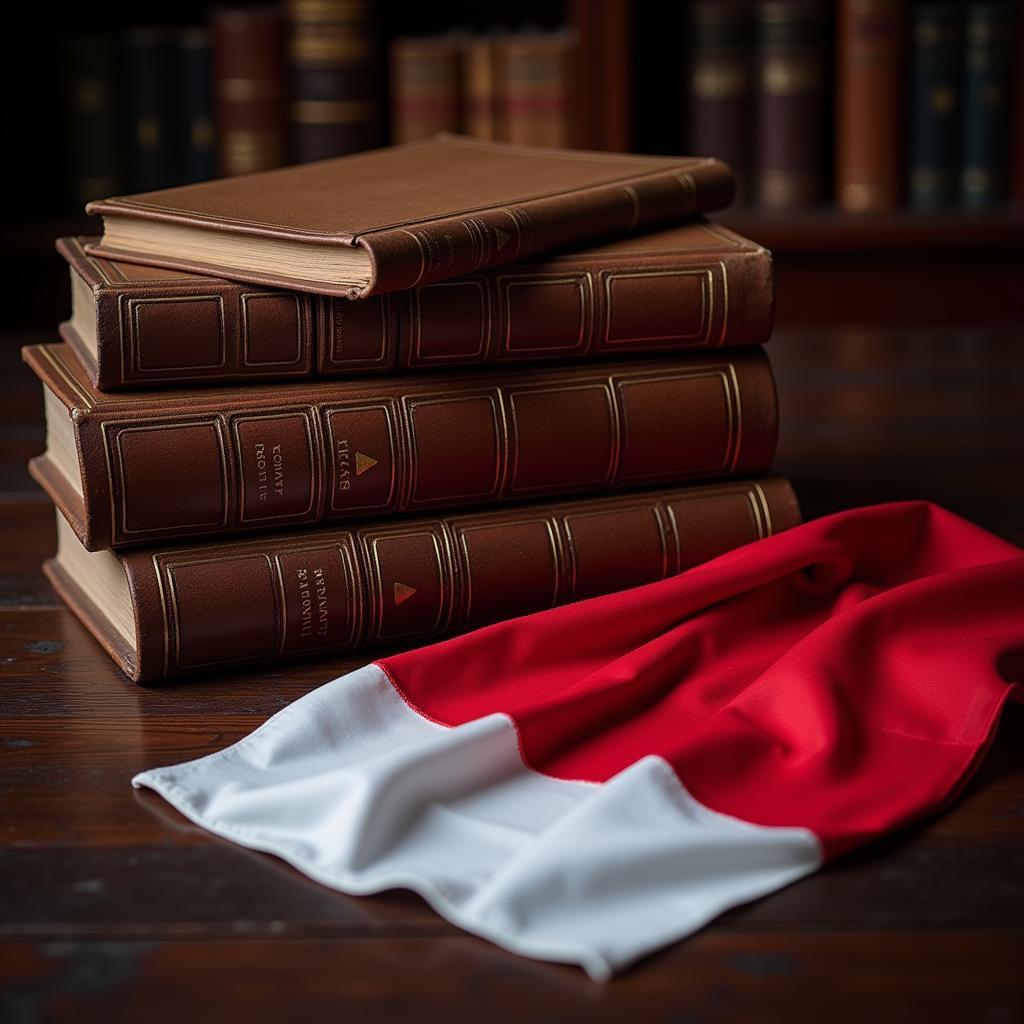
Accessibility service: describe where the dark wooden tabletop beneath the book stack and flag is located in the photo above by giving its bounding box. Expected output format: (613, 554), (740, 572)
(0, 329), (1024, 1024)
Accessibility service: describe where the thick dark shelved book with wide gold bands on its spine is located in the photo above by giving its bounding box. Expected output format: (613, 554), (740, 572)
(287, 0), (380, 163)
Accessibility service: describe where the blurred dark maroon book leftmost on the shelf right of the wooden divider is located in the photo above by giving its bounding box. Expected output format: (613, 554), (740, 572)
(687, 0), (752, 202)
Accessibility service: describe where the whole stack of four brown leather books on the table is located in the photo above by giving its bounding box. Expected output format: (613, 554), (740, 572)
(25, 136), (799, 681)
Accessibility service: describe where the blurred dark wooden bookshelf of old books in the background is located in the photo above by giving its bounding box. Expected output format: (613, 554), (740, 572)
(3, 0), (1024, 325)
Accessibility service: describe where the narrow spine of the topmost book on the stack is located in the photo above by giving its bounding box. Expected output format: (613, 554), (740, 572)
(356, 159), (734, 299)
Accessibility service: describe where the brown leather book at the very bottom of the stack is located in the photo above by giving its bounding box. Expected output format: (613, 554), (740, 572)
(44, 477), (800, 682)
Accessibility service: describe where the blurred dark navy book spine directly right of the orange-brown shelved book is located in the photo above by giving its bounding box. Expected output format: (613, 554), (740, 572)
(907, 0), (964, 210)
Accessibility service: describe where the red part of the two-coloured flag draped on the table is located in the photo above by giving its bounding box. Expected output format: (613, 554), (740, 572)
(379, 502), (1024, 855)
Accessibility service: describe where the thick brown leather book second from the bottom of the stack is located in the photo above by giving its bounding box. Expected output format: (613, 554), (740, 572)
(25, 345), (776, 550)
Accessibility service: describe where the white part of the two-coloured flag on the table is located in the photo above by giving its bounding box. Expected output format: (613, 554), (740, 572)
(133, 665), (821, 979)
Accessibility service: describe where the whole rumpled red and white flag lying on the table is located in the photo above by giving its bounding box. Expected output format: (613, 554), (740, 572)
(134, 503), (1024, 979)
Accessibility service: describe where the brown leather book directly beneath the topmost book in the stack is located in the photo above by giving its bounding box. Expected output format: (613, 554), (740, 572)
(57, 220), (773, 390)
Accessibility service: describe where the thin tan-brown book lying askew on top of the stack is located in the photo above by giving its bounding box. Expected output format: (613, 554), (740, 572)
(86, 135), (733, 299)
